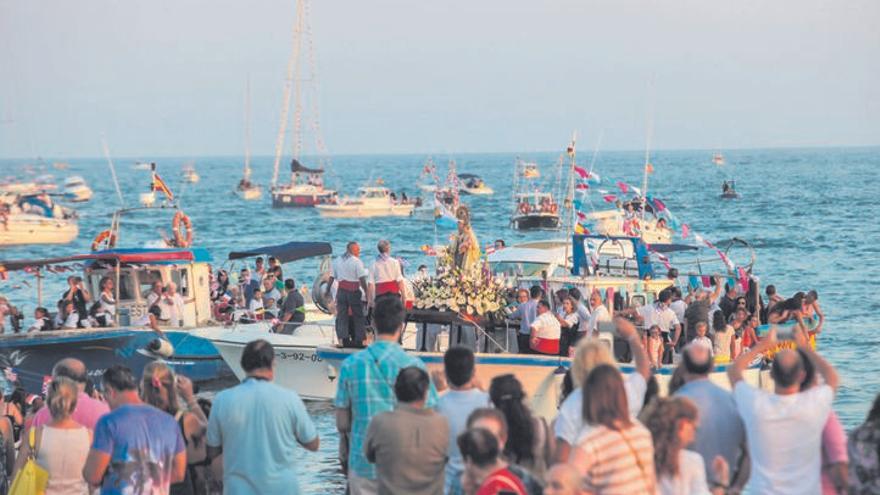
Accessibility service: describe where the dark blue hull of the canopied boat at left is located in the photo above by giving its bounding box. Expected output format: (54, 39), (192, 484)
(0, 328), (232, 393)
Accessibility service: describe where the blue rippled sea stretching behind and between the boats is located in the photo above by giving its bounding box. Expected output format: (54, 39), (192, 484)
(0, 148), (880, 493)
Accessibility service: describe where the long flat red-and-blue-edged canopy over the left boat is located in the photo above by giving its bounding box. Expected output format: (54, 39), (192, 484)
(0, 248), (211, 271)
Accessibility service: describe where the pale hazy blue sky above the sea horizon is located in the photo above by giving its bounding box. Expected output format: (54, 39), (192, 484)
(0, 0), (880, 158)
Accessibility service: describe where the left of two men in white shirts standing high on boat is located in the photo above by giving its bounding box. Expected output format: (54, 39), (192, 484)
(327, 241), (369, 347)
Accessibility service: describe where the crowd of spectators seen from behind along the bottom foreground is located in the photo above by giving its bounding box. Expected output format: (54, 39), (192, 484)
(0, 297), (880, 495)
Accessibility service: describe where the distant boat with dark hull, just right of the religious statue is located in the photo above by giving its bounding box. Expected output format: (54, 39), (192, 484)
(510, 158), (562, 230)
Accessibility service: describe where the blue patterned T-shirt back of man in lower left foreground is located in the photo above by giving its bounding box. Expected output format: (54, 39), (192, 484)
(92, 404), (185, 495)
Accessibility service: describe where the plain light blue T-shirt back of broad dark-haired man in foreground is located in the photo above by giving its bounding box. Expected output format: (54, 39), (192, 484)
(208, 378), (317, 494)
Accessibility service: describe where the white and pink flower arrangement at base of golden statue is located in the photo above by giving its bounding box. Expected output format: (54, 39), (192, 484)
(413, 250), (507, 316)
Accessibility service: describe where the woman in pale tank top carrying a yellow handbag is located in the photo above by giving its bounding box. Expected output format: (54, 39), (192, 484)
(15, 377), (92, 495)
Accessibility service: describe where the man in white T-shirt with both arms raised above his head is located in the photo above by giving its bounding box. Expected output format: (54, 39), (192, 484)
(727, 327), (839, 495)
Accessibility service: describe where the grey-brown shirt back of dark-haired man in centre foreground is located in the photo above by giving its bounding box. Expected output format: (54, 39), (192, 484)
(365, 404), (449, 495)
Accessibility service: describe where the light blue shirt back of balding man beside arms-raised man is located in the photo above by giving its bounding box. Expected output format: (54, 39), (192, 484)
(675, 379), (746, 481)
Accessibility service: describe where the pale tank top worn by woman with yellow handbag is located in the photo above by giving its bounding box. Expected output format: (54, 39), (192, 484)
(35, 426), (91, 495)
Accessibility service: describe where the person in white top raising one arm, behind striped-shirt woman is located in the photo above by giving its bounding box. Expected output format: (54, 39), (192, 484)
(553, 318), (651, 462)
